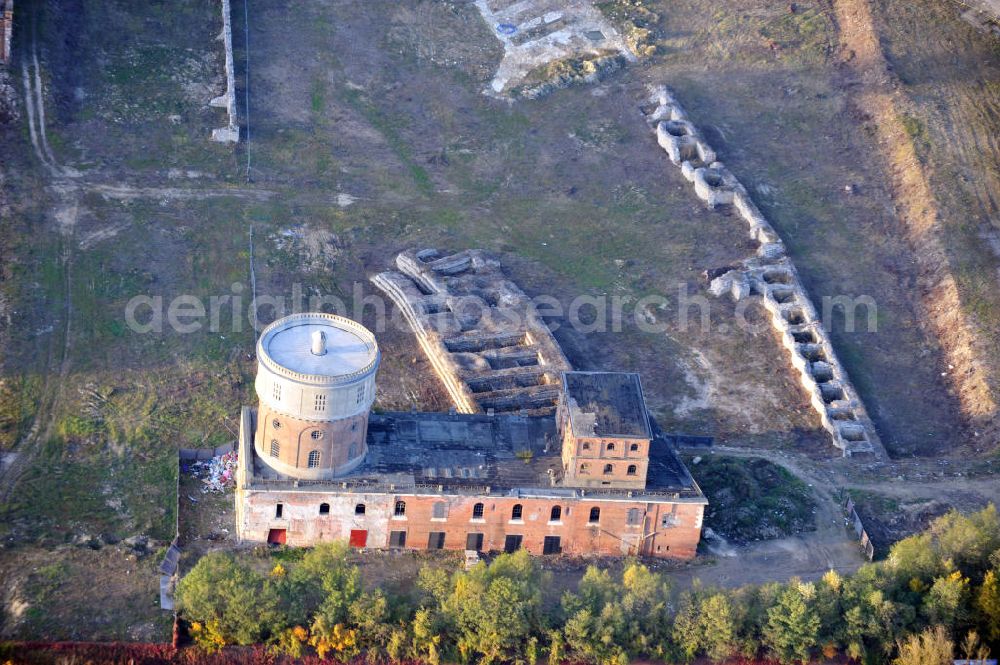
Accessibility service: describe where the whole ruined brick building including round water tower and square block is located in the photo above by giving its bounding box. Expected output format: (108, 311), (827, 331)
(236, 314), (707, 558)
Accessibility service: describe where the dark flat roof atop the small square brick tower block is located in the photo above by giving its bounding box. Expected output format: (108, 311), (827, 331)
(563, 372), (652, 439)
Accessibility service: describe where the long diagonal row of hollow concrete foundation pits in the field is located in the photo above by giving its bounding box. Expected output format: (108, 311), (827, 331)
(647, 86), (882, 456)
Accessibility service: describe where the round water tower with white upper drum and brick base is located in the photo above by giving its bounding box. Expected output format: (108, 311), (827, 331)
(254, 313), (380, 480)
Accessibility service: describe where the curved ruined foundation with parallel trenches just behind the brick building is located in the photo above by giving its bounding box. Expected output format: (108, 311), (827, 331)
(371, 249), (572, 413)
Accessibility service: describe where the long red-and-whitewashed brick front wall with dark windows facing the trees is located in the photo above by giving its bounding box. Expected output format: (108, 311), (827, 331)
(237, 488), (704, 559)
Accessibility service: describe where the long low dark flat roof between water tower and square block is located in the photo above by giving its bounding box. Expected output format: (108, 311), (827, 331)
(252, 412), (702, 498)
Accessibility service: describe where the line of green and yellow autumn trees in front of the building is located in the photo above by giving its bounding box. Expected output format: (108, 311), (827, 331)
(176, 505), (1000, 665)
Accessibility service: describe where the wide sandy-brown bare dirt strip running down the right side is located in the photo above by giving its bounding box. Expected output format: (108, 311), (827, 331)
(833, 0), (997, 440)
